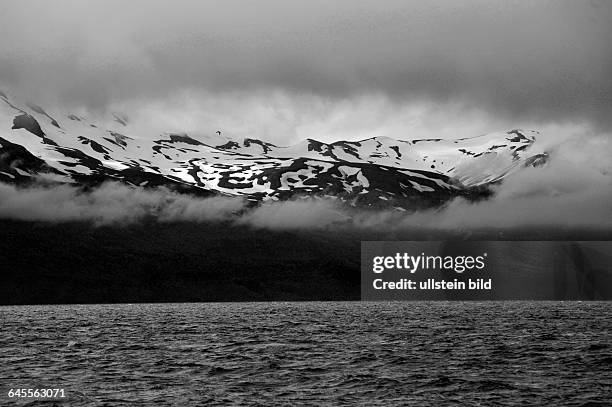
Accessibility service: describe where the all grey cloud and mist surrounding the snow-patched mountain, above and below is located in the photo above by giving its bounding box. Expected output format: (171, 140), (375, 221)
(0, 0), (612, 228)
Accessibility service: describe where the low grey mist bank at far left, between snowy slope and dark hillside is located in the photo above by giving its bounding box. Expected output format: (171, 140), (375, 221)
(0, 182), (243, 225)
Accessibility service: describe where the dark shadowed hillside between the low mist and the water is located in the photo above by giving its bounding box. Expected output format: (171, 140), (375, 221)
(0, 221), (612, 304)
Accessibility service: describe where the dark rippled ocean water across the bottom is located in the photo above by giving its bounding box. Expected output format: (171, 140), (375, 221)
(0, 302), (612, 406)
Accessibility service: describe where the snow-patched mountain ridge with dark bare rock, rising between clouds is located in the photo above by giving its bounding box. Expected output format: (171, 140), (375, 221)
(0, 92), (547, 209)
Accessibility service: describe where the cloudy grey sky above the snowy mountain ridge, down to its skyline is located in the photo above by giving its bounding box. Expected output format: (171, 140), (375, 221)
(0, 0), (612, 145)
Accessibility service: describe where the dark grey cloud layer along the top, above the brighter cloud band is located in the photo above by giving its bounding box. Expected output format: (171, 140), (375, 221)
(0, 0), (612, 129)
